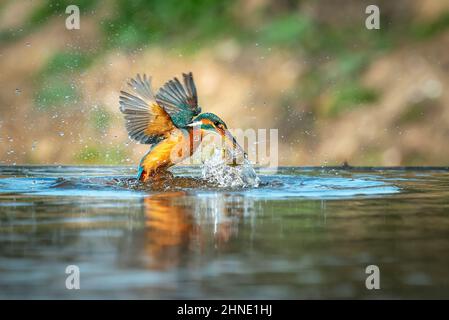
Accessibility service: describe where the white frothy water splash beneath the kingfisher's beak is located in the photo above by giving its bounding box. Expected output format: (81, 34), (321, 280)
(201, 149), (260, 188)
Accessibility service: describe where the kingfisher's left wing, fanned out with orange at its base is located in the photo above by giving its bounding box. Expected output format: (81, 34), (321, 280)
(120, 74), (175, 144)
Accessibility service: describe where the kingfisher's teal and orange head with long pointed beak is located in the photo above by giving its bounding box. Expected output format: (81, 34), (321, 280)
(188, 113), (247, 158)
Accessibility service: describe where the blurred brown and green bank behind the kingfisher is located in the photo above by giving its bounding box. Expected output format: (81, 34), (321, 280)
(0, 0), (449, 165)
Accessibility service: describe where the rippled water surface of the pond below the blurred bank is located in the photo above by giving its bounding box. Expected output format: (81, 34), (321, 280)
(0, 166), (449, 299)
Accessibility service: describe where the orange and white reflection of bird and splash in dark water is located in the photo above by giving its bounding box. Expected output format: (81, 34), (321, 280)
(139, 191), (251, 269)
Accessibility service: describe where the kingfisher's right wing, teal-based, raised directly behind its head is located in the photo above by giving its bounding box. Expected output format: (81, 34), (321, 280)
(156, 72), (201, 128)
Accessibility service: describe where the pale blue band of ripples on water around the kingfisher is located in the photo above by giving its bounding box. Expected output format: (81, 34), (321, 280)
(0, 167), (400, 199)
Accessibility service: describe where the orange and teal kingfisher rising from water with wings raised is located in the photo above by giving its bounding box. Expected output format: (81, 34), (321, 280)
(119, 72), (240, 182)
